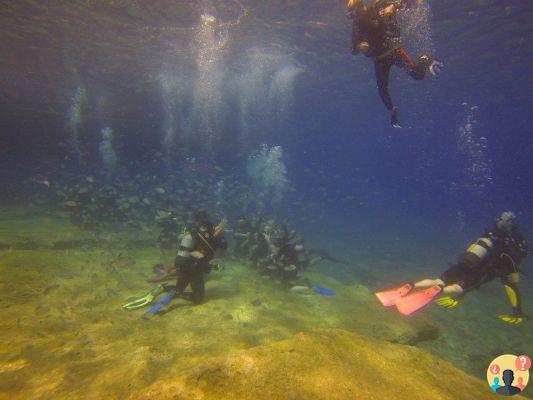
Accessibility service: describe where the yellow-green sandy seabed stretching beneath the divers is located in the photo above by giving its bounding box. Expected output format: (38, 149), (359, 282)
(0, 207), (533, 399)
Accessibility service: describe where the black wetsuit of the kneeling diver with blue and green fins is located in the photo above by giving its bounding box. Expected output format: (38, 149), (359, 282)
(174, 231), (227, 304)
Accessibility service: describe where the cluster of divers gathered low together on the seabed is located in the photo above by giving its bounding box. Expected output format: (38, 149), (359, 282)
(123, 211), (334, 317)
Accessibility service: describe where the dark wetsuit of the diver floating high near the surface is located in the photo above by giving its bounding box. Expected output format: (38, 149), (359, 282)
(351, 1), (426, 124)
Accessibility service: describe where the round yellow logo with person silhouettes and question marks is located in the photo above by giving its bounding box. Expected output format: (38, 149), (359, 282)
(487, 354), (531, 396)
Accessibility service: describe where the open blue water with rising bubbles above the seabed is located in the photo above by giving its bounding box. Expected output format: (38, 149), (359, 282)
(0, 0), (533, 396)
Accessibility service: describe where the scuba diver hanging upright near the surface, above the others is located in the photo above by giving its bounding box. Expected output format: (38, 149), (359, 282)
(348, 0), (444, 128)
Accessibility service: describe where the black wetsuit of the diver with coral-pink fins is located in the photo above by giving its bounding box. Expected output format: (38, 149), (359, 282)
(441, 229), (528, 293)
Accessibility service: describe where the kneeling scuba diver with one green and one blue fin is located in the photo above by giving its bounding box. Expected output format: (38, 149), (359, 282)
(122, 212), (227, 317)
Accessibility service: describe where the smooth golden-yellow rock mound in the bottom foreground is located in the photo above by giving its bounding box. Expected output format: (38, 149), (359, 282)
(130, 330), (508, 400)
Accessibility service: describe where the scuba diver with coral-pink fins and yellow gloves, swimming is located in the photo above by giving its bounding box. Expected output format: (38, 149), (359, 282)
(376, 211), (528, 324)
